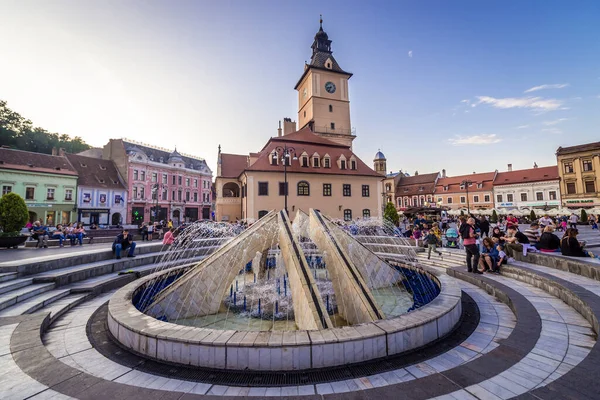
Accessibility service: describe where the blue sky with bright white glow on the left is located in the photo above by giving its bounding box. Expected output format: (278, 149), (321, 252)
(0, 0), (600, 175)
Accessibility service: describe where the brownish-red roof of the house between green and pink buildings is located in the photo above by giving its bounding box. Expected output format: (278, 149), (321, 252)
(67, 154), (124, 189)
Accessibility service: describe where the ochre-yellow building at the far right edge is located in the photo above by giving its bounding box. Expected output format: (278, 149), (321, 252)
(556, 142), (600, 208)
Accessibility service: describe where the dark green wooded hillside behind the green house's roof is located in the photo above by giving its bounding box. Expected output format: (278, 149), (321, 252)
(0, 100), (90, 154)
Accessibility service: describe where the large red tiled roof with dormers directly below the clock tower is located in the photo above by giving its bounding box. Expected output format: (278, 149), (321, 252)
(246, 128), (384, 179)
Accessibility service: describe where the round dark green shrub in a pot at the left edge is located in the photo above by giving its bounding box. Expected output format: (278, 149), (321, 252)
(0, 193), (29, 248)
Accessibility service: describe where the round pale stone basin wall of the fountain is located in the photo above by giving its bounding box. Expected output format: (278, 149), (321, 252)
(108, 264), (462, 371)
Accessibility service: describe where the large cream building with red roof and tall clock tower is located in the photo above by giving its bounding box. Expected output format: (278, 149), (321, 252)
(215, 21), (384, 221)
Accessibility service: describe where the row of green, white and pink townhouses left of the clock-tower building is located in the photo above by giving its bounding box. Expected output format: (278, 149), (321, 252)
(0, 139), (213, 225)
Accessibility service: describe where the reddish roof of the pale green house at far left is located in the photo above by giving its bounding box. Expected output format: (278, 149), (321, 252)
(0, 148), (77, 176)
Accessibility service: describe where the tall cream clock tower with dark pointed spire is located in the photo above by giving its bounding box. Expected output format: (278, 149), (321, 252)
(294, 19), (355, 147)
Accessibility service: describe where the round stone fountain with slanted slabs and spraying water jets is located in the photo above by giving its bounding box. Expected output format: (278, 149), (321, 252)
(108, 209), (461, 371)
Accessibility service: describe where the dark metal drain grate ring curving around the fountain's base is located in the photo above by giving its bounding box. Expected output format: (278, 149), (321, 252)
(86, 292), (480, 387)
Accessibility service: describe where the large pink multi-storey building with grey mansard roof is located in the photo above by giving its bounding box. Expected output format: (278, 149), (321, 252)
(102, 139), (212, 225)
